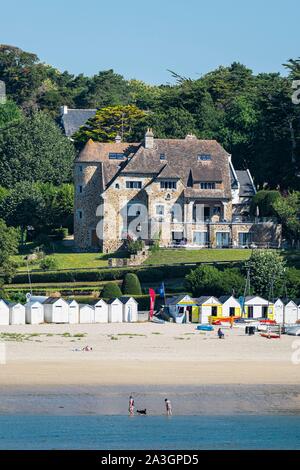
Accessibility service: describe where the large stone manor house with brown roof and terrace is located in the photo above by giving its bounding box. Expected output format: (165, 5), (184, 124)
(74, 129), (281, 253)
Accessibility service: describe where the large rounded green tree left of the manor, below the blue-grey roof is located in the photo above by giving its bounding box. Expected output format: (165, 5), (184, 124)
(0, 112), (75, 187)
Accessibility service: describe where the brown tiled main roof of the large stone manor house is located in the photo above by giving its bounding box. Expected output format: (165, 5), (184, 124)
(76, 137), (231, 199)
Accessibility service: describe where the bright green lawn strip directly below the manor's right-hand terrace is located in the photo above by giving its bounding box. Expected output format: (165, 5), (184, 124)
(144, 248), (251, 264)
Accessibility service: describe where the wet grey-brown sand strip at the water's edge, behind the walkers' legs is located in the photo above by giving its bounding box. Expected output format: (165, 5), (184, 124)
(0, 385), (300, 416)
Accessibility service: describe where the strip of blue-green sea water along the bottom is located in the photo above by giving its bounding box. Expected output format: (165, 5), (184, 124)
(0, 415), (300, 450)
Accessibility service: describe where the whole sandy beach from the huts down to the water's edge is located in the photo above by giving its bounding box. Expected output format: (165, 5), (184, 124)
(0, 323), (300, 414)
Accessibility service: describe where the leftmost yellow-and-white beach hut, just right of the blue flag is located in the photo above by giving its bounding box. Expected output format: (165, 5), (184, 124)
(164, 294), (199, 323)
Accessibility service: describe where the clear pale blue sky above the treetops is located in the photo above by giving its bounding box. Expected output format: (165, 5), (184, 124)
(0, 0), (300, 83)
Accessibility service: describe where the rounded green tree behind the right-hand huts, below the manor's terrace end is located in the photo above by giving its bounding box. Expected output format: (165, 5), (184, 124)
(247, 250), (285, 297)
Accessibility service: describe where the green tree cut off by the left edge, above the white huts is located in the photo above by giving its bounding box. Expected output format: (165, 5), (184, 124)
(0, 219), (19, 280)
